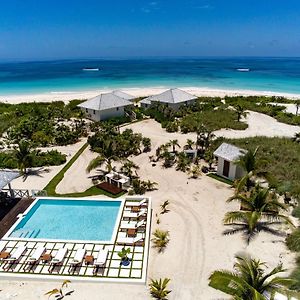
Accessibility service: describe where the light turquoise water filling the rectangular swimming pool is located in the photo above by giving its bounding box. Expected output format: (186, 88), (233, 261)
(10, 199), (121, 241)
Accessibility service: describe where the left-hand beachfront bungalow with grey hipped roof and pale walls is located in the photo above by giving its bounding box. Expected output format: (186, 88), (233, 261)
(78, 91), (133, 121)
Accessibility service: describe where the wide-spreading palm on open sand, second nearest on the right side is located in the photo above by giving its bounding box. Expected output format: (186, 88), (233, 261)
(223, 211), (294, 244)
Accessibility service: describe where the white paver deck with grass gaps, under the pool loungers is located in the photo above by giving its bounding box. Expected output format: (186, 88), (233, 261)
(0, 197), (151, 283)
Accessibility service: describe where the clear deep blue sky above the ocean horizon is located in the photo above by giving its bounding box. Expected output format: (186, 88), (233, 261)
(0, 0), (300, 60)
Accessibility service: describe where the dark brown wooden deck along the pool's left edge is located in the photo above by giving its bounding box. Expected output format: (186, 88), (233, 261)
(0, 198), (35, 238)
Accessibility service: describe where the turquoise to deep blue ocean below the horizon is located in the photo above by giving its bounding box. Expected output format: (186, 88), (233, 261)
(0, 57), (300, 96)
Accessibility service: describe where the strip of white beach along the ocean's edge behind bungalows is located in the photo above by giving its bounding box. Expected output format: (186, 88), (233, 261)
(0, 86), (300, 104)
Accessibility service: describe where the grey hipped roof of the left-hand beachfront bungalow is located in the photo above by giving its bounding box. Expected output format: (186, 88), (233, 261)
(78, 93), (132, 111)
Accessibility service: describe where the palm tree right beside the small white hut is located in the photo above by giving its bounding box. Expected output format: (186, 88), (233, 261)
(235, 147), (270, 191)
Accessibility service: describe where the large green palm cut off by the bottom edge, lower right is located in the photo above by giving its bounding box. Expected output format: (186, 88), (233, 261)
(209, 255), (298, 300)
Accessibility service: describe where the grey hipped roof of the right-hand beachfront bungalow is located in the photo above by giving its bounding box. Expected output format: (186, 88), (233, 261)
(142, 89), (197, 103)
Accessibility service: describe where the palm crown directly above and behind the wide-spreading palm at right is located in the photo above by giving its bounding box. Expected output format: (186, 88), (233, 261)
(227, 185), (287, 216)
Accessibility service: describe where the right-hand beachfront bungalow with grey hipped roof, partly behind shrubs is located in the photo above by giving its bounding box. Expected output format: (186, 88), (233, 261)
(140, 88), (197, 110)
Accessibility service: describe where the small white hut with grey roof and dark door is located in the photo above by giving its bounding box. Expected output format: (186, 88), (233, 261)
(214, 143), (247, 180)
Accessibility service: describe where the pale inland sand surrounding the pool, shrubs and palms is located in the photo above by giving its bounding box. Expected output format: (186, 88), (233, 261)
(4, 113), (300, 300)
